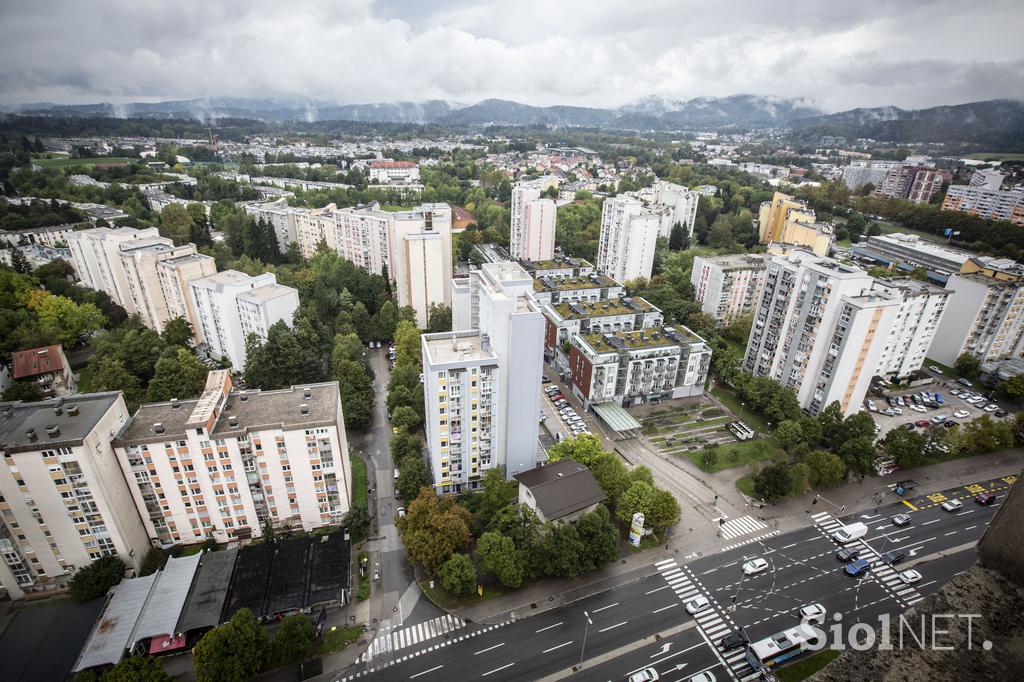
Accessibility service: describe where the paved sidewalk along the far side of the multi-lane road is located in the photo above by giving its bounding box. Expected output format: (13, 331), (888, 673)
(451, 447), (1024, 623)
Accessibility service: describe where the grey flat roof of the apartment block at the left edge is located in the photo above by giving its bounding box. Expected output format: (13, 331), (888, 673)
(0, 391), (121, 453)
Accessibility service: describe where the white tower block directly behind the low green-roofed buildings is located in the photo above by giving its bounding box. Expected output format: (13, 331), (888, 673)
(597, 197), (660, 282)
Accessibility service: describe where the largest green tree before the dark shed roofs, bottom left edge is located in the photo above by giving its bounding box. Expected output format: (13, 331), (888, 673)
(193, 608), (269, 682)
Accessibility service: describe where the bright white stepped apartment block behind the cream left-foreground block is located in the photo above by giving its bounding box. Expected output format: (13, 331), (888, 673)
(188, 270), (299, 370)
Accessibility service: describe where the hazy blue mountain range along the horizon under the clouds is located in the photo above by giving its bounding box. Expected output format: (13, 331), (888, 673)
(2, 94), (1024, 148)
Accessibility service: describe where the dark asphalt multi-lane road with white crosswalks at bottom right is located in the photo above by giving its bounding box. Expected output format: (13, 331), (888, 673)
(338, 473), (1015, 682)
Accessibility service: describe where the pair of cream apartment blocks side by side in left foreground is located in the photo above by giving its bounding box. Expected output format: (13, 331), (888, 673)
(0, 371), (352, 598)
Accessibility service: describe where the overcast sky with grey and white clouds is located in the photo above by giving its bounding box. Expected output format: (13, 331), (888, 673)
(0, 0), (1024, 111)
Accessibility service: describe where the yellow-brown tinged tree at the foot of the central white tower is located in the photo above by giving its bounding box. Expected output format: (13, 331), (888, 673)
(398, 487), (472, 576)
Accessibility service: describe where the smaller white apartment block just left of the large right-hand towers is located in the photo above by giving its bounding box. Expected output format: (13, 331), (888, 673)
(690, 254), (771, 326)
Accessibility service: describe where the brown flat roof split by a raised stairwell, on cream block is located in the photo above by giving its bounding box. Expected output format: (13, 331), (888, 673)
(114, 381), (339, 447)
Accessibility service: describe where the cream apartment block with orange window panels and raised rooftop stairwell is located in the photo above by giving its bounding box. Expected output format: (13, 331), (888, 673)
(114, 371), (352, 547)
